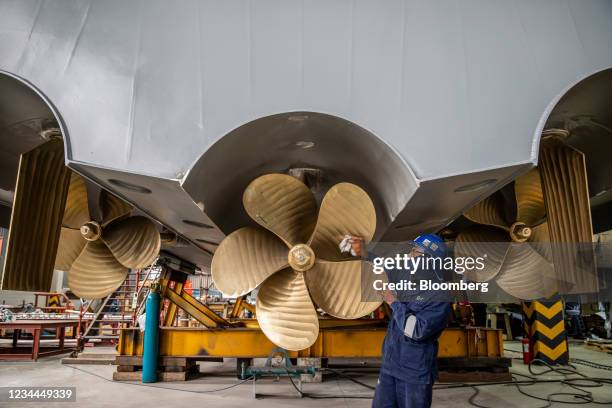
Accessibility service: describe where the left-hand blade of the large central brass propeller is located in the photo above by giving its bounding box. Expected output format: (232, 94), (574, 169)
(211, 227), (288, 296)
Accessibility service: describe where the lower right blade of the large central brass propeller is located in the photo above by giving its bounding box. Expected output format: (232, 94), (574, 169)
(305, 260), (384, 319)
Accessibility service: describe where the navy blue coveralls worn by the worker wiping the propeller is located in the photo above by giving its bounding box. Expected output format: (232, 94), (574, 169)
(372, 262), (451, 408)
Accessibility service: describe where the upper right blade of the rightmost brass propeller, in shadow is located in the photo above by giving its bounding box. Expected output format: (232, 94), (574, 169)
(514, 168), (546, 227)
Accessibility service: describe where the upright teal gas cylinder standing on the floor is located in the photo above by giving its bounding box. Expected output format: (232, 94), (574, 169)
(142, 290), (160, 383)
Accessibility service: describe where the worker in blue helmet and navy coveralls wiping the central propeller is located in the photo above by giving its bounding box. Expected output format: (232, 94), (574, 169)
(349, 234), (451, 408)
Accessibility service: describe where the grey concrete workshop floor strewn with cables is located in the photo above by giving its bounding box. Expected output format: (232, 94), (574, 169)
(0, 342), (612, 408)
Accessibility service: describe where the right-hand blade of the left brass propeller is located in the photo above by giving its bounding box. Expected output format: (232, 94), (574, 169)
(102, 216), (161, 269)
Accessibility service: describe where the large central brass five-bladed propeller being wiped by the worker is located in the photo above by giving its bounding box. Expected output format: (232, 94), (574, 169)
(211, 174), (381, 350)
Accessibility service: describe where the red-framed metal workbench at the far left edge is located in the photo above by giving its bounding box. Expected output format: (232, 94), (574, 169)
(0, 319), (79, 361)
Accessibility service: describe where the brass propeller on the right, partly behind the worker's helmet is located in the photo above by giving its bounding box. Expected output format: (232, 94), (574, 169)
(455, 168), (557, 300)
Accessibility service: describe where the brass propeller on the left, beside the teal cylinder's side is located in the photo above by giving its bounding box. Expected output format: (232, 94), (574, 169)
(55, 172), (161, 299)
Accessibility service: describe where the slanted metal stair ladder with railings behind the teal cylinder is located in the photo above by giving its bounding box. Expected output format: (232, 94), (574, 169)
(81, 267), (156, 343)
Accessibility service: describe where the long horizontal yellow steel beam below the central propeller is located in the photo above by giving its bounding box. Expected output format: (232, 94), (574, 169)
(119, 327), (503, 358)
